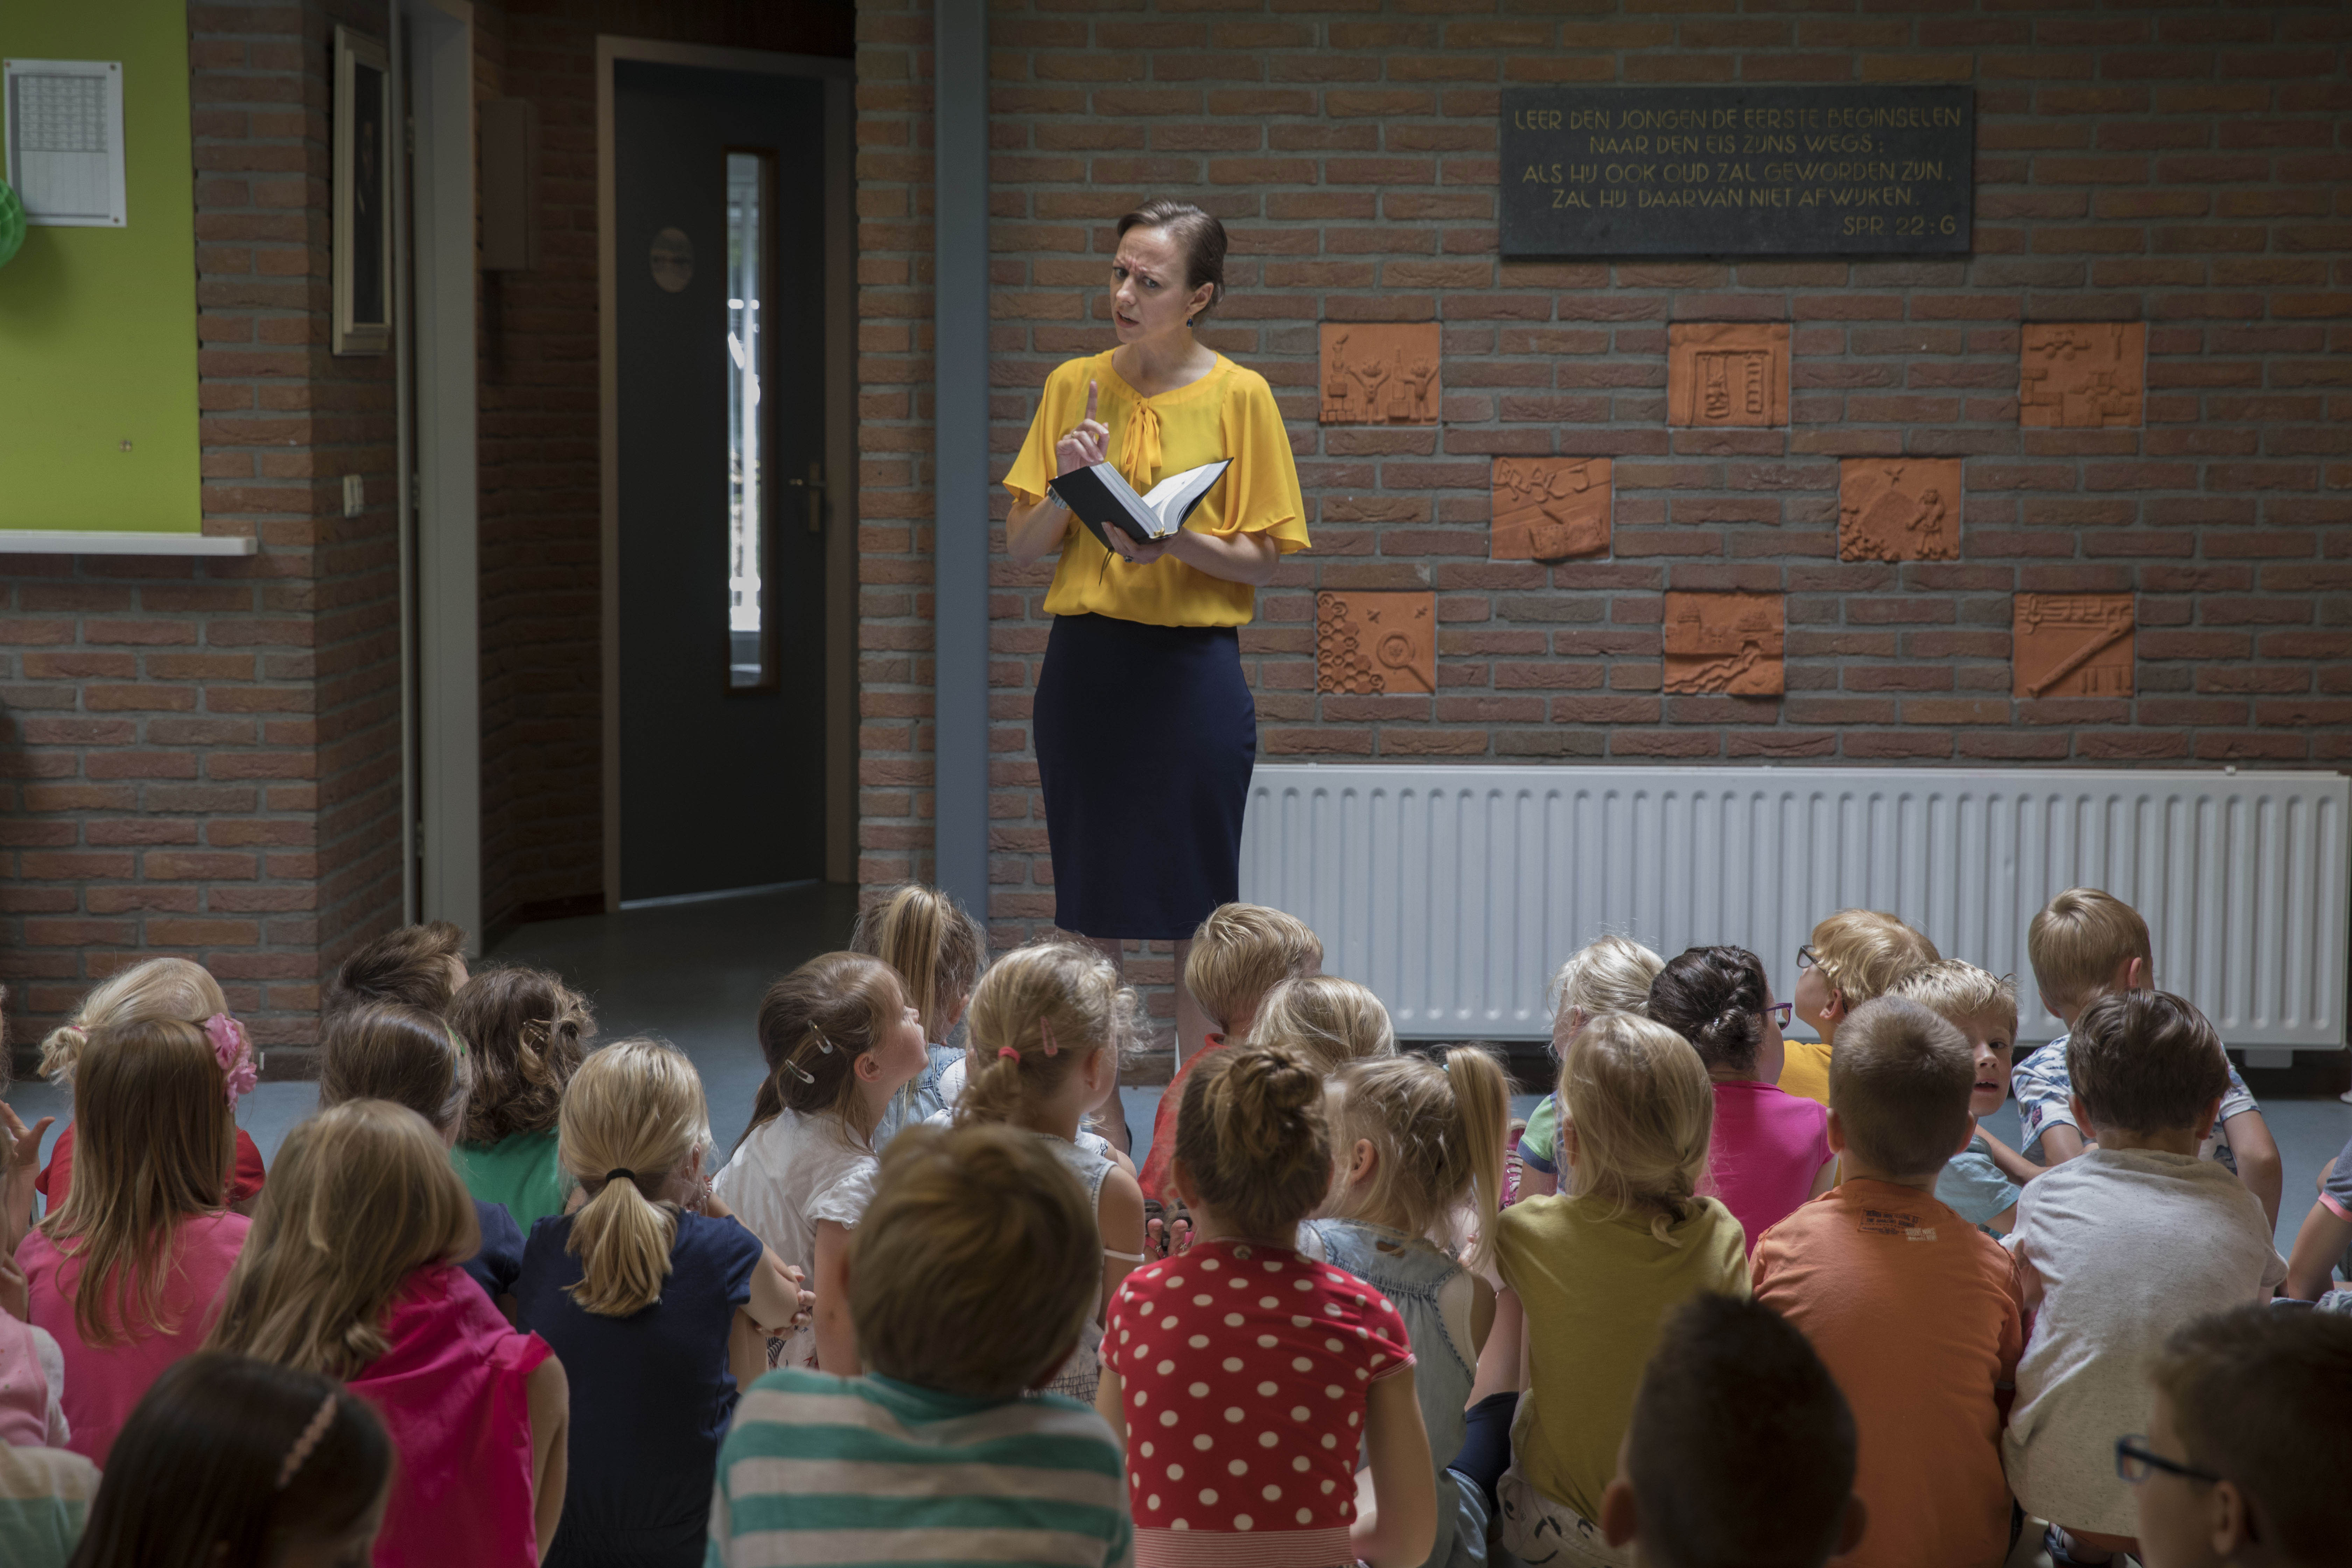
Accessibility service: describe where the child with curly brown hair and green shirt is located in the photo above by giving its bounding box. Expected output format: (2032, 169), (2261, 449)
(449, 966), (595, 1237)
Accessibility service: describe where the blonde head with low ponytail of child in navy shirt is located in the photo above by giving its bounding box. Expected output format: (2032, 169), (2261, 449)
(558, 1039), (710, 1316)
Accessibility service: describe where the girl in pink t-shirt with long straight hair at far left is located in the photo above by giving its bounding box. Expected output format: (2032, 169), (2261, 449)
(16, 1013), (259, 1469)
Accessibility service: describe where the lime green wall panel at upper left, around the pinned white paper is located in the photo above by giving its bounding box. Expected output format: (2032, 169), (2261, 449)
(0, 0), (202, 534)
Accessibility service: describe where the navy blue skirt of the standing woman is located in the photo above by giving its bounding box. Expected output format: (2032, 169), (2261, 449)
(1030, 616), (1258, 940)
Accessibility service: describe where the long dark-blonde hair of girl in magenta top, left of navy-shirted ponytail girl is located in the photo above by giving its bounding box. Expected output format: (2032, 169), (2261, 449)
(208, 1100), (482, 1378)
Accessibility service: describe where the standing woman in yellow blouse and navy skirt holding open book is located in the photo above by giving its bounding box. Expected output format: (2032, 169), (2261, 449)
(1004, 200), (1308, 1060)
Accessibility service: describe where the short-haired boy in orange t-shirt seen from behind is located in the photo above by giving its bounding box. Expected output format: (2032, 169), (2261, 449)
(1750, 997), (2025, 1568)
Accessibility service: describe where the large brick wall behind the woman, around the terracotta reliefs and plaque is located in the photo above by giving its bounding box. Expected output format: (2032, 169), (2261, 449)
(859, 0), (2352, 1048)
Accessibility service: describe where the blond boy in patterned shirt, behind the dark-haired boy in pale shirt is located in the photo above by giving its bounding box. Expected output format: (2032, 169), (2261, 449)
(2011, 889), (2284, 1225)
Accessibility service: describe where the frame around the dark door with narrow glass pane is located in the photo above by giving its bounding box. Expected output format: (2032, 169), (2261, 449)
(595, 33), (859, 910)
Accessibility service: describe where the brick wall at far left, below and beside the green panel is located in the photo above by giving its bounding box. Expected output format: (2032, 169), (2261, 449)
(0, 2), (400, 1074)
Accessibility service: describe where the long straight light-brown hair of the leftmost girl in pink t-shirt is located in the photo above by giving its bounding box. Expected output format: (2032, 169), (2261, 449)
(40, 1020), (238, 1345)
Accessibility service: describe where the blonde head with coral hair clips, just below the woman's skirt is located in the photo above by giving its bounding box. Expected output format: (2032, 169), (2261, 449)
(955, 938), (1141, 1121)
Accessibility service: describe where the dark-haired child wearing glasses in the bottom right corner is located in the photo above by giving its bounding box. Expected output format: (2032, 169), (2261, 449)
(2114, 1307), (2352, 1568)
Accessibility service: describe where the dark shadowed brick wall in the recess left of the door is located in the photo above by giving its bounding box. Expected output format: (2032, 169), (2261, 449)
(475, 0), (852, 929)
